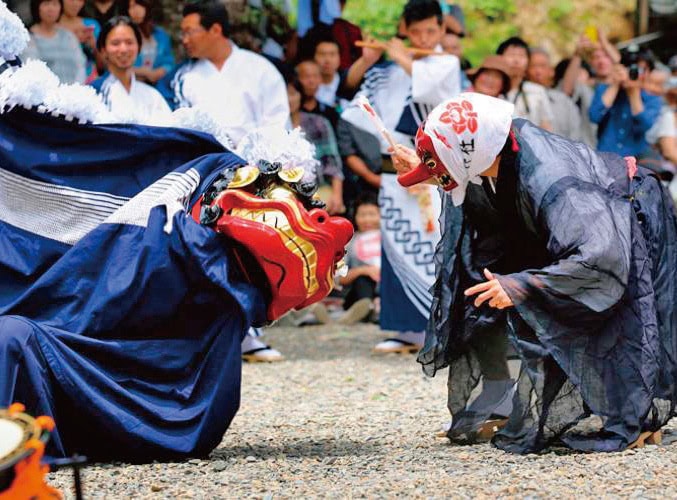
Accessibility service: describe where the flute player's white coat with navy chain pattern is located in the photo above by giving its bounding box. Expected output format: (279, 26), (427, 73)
(341, 47), (461, 320)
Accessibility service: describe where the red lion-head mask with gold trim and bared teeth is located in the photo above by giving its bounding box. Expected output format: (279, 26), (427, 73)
(187, 163), (353, 321)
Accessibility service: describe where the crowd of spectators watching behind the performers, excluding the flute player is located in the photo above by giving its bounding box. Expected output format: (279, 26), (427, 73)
(10, 0), (677, 360)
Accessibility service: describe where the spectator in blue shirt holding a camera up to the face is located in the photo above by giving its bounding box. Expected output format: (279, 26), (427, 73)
(589, 47), (661, 156)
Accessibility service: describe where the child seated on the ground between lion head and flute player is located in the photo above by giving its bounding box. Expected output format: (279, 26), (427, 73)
(338, 193), (381, 325)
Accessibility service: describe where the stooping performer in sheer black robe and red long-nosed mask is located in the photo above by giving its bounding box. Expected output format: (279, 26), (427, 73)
(394, 94), (677, 453)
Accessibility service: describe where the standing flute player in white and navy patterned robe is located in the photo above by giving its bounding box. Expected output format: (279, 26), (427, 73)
(341, 0), (460, 353)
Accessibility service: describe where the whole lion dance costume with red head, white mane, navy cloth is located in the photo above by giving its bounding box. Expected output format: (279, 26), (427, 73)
(0, 3), (352, 461)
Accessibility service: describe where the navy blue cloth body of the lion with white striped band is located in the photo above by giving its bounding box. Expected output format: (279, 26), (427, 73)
(0, 106), (265, 461)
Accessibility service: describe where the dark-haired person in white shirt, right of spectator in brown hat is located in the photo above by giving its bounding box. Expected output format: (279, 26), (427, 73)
(496, 36), (553, 131)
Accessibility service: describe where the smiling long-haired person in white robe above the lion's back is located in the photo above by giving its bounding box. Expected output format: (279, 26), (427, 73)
(91, 16), (171, 125)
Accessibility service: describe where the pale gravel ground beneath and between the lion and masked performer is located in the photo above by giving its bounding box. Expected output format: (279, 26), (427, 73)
(50, 325), (677, 499)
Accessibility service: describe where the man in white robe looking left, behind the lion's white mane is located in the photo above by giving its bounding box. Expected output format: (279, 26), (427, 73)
(161, 1), (289, 145)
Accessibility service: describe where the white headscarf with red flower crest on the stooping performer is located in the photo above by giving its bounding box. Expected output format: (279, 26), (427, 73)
(417, 92), (514, 206)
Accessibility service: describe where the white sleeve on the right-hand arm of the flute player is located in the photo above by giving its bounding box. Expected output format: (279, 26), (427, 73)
(411, 54), (461, 106)
